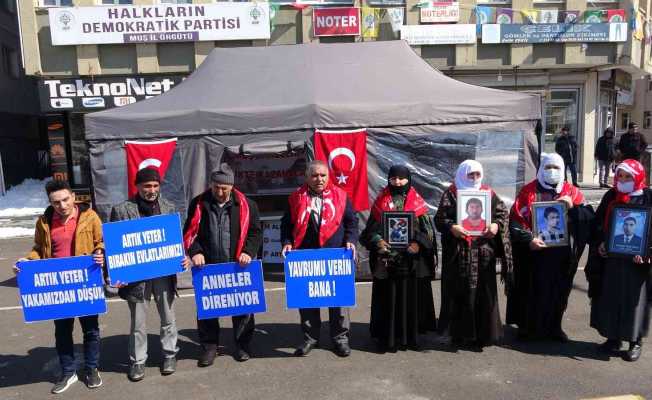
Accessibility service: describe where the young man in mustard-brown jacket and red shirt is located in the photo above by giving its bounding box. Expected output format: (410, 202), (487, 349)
(14, 180), (104, 394)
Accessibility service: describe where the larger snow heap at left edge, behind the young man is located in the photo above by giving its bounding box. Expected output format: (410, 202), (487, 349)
(0, 179), (48, 217)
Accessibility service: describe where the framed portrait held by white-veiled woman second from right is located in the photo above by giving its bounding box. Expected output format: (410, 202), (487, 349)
(532, 201), (570, 247)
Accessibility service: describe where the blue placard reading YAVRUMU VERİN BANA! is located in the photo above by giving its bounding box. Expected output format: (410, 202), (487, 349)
(285, 249), (355, 308)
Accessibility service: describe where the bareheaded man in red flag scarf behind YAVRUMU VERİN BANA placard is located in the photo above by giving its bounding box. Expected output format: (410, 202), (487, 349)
(281, 161), (358, 357)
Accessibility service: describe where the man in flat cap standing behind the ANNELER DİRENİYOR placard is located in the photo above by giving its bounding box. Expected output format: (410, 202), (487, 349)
(183, 164), (262, 367)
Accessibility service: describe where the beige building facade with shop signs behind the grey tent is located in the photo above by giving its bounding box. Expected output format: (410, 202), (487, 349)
(19, 0), (652, 192)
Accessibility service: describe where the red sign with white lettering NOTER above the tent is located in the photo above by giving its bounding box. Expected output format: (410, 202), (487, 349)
(312, 7), (360, 37)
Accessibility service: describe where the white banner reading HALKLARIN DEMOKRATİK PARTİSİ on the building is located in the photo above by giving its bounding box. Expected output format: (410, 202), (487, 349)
(48, 3), (270, 46)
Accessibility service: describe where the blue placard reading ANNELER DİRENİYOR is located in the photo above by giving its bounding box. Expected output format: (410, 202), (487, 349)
(192, 260), (267, 319)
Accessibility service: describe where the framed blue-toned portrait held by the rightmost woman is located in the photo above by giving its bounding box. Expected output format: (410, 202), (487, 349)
(607, 205), (651, 258)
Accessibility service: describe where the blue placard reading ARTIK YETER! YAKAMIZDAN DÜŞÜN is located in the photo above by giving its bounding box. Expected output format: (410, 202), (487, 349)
(17, 256), (106, 322)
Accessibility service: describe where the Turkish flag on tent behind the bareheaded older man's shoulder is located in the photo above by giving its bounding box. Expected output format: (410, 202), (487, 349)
(314, 129), (369, 211)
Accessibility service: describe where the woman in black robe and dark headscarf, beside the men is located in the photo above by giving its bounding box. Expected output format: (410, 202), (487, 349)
(360, 165), (437, 351)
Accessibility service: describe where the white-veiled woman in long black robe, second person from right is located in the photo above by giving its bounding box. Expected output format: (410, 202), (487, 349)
(506, 153), (593, 342)
